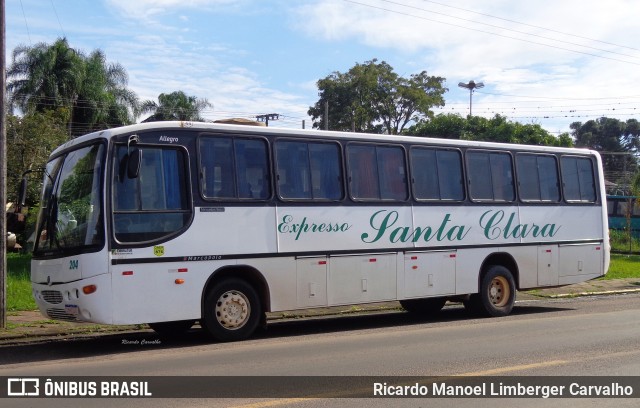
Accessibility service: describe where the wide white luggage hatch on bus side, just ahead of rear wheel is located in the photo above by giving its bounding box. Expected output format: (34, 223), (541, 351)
(404, 251), (456, 298)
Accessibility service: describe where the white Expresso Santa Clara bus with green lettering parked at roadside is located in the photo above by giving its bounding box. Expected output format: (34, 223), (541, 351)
(31, 122), (609, 341)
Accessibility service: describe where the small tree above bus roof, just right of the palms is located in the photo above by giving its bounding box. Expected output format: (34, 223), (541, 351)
(140, 91), (213, 122)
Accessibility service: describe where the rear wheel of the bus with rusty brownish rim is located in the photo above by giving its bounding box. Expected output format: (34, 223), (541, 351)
(478, 265), (516, 317)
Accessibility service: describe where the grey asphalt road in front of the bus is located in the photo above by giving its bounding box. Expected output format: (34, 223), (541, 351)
(0, 294), (640, 408)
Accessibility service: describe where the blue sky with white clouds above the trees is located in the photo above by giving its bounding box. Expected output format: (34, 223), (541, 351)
(5, 0), (640, 134)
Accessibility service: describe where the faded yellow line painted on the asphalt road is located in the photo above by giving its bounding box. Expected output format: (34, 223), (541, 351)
(232, 360), (571, 408)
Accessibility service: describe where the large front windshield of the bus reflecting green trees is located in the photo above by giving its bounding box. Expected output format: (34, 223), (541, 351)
(34, 144), (105, 256)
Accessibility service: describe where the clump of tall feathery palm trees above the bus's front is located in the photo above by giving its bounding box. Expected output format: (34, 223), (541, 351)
(7, 38), (138, 136)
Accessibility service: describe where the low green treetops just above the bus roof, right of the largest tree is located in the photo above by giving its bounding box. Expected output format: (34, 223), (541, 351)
(405, 113), (573, 147)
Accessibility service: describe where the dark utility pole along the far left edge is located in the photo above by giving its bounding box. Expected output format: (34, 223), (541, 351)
(0, 0), (7, 329)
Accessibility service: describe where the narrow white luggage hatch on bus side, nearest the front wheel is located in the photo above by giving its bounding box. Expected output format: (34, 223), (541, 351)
(296, 256), (327, 307)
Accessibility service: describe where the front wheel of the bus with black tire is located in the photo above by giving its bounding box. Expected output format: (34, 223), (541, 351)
(201, 279), (262, 341)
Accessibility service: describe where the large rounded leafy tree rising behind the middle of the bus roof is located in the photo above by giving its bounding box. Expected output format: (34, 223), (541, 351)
(308, 59), (447, 134)
